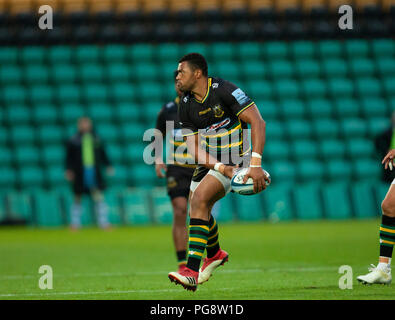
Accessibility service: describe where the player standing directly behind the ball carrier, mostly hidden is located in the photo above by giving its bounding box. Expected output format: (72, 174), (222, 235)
(155, 72), (196, 272)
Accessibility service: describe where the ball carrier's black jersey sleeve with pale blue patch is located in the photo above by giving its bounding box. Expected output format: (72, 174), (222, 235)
(218, 80), (254, 116)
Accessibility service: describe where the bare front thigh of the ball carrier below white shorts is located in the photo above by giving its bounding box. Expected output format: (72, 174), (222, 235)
(191, 174), (226, 207)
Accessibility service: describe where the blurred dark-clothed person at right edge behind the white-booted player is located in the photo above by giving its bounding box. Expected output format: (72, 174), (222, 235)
(375, 111), (395, 183)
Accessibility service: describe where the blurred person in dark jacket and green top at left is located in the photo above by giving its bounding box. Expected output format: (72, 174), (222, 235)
(65, 117), (114, 230)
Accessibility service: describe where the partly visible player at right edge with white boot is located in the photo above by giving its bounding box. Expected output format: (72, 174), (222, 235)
(357, 149), (395, 284)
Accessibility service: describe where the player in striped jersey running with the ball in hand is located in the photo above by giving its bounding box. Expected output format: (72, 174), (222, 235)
(168, 53), (269, 291)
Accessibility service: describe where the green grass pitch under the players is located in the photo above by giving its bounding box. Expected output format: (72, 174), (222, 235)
(0, 219), (395, 300)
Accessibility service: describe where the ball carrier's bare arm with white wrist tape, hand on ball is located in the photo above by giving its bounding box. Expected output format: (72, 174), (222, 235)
(239, 104), (269, 193)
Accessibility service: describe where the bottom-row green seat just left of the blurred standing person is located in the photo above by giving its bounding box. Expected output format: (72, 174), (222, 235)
(32, 190), (63, 227)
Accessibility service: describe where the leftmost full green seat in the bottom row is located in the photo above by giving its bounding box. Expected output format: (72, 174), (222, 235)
(6, 190), (33, 223)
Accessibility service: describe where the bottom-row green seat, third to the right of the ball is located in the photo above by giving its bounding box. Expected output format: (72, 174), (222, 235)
(322, 182), (352, 219)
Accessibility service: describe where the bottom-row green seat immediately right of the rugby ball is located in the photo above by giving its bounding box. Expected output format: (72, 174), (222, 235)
(263, 184), (295, 222)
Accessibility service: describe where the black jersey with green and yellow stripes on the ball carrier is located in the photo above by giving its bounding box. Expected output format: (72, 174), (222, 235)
(178, 78), (254, 164)
